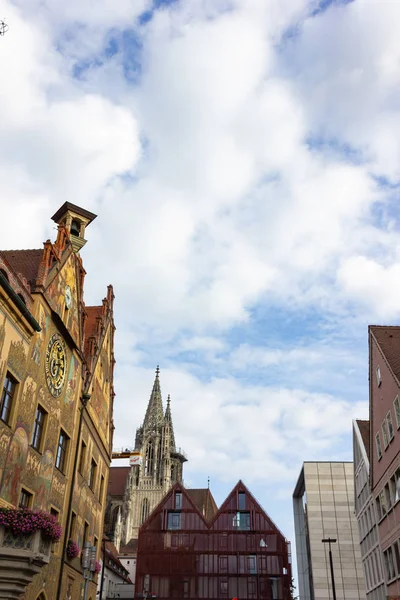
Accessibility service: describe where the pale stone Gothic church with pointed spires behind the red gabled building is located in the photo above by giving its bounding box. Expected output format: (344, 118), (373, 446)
(105, 367), (187, 548)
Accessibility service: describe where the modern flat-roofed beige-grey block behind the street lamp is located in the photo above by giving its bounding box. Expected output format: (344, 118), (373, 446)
(293, 462), (366, 600)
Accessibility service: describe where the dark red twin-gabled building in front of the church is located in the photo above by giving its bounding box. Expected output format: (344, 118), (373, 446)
(135, 481), (292, 600)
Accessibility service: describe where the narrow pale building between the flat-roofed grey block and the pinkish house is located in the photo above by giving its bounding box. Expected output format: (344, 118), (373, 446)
(353, 420), (387, 600)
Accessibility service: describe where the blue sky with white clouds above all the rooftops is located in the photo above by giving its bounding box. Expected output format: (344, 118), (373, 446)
(0, 0), (400, 592)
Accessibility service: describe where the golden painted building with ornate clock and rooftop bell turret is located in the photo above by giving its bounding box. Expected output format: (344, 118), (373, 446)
(0, 202), (115, 600)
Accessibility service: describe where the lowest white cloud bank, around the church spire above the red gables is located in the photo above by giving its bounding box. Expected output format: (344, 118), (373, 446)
(111, 366), (368, 485)
